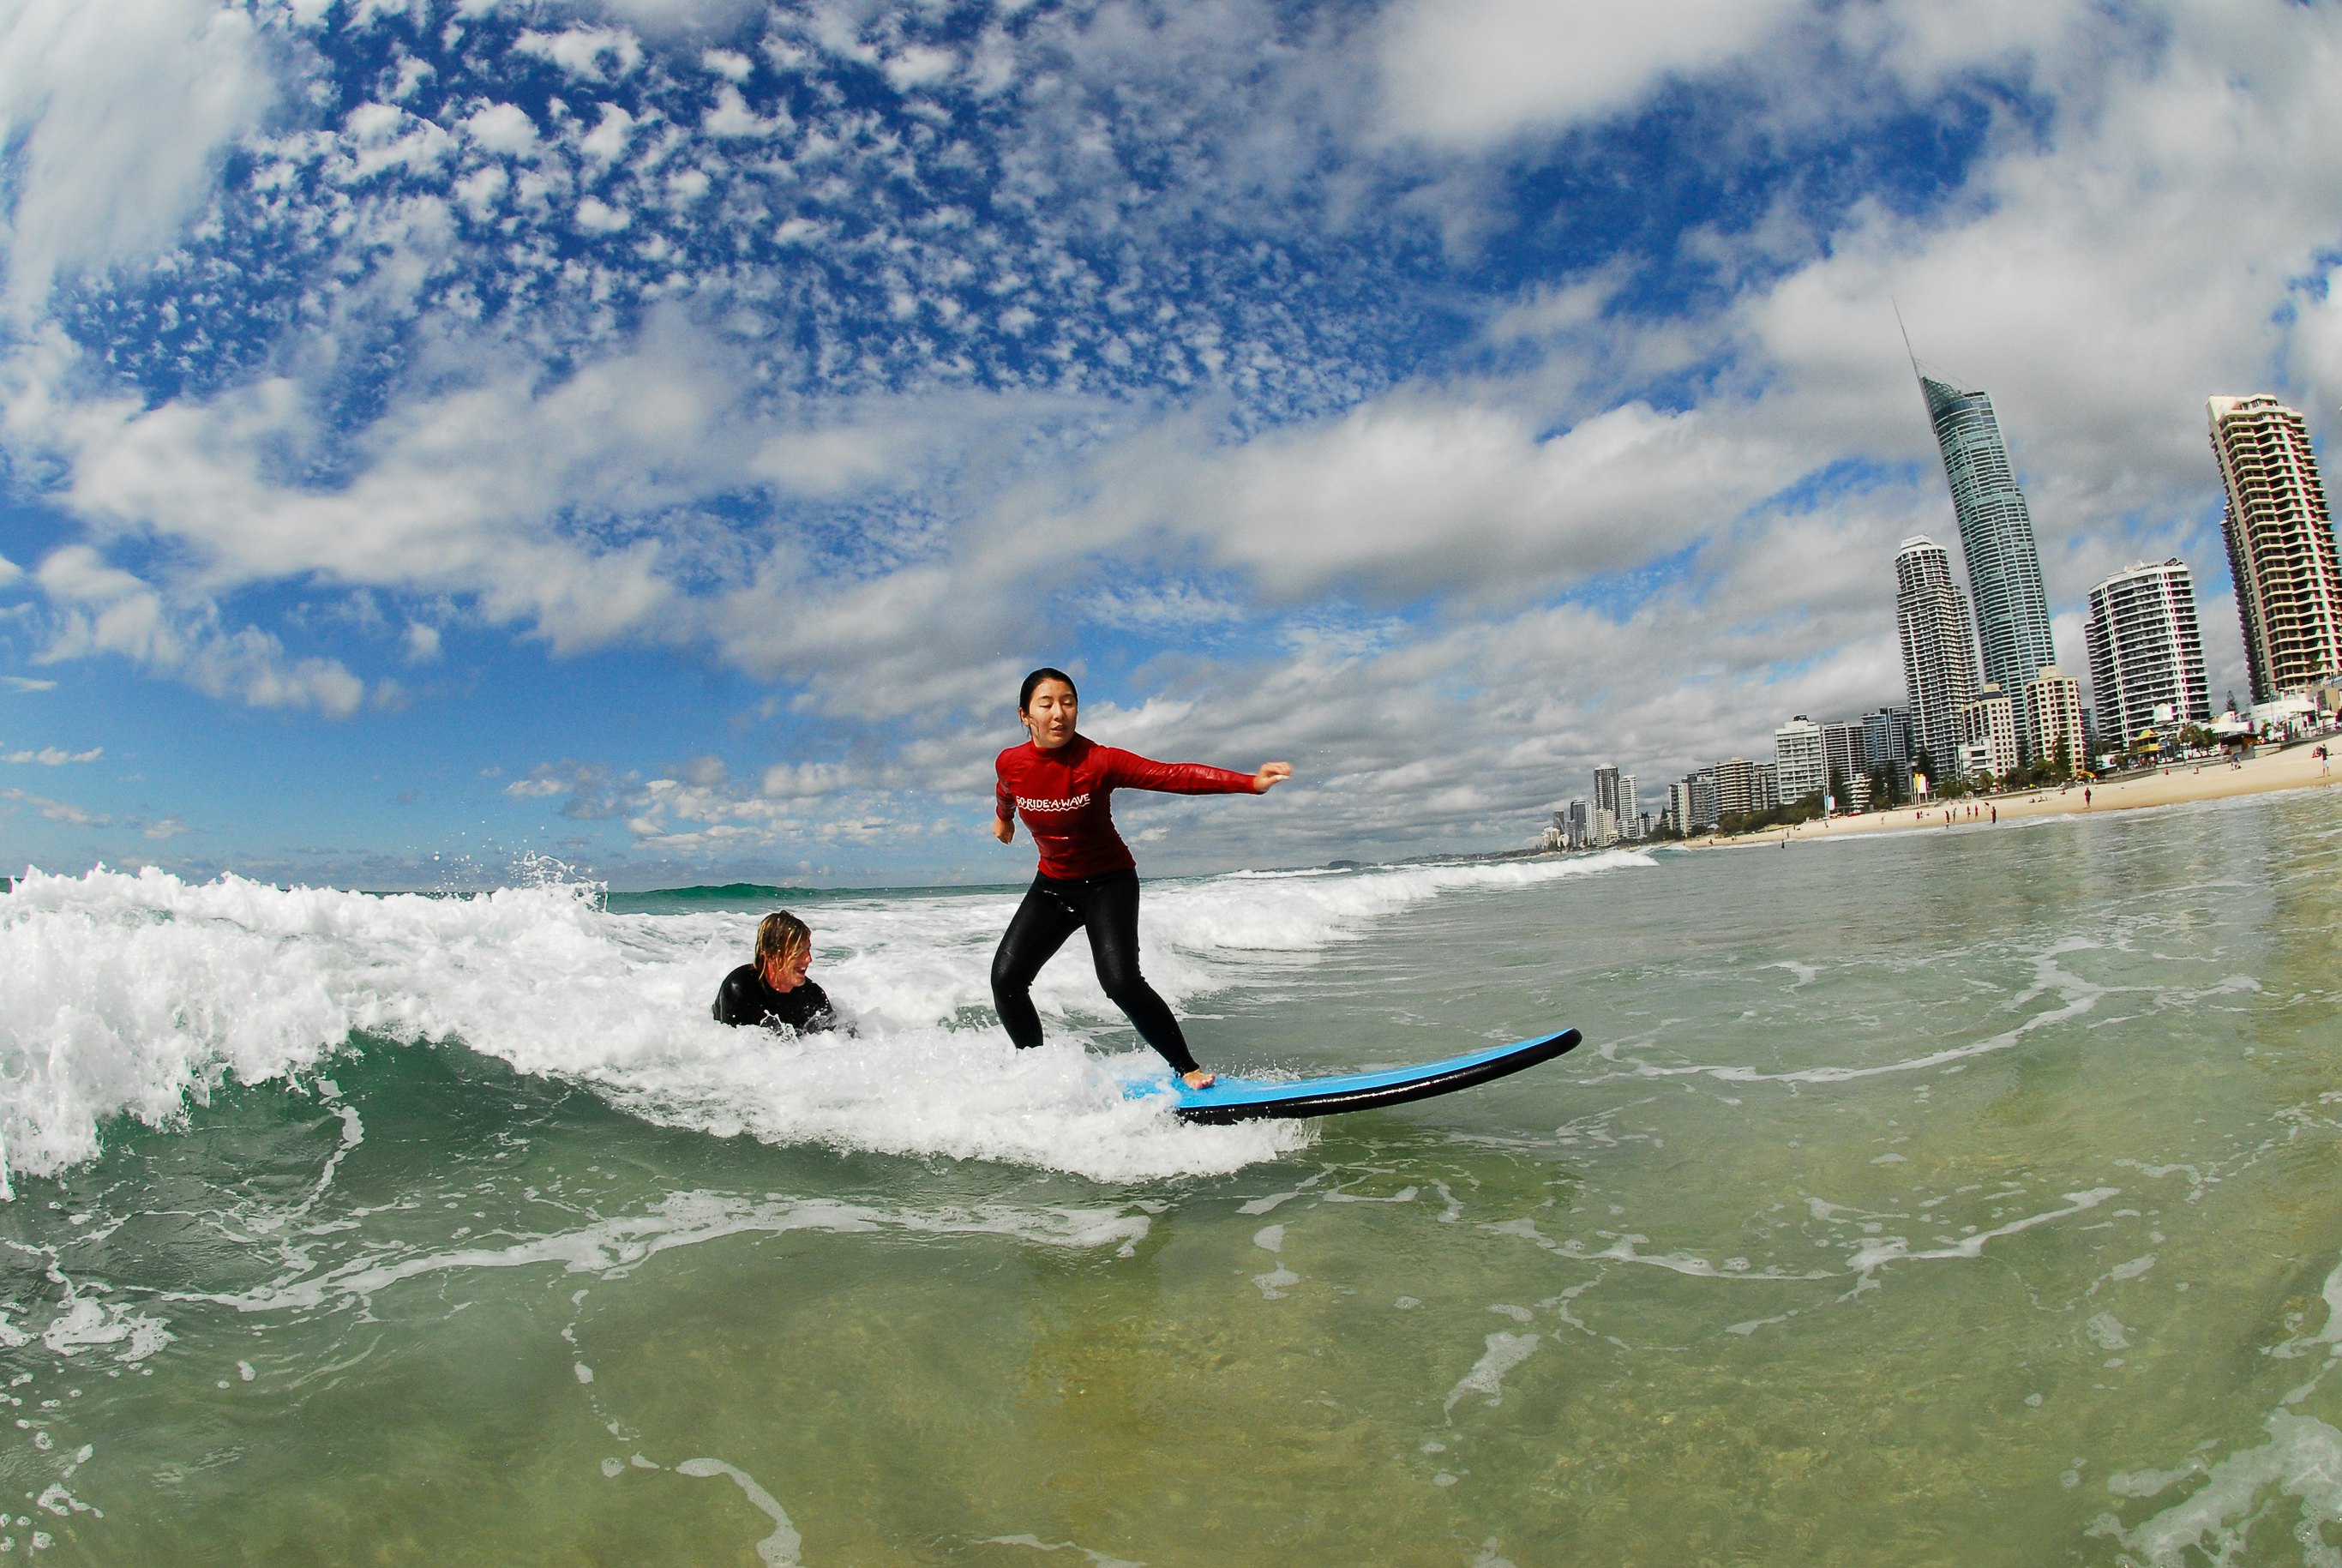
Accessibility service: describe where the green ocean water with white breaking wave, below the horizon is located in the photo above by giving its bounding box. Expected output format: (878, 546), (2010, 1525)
(0, 792), (2342, 1568)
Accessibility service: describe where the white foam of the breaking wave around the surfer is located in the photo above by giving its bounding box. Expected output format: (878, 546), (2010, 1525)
(0, 853), (1651, 1181)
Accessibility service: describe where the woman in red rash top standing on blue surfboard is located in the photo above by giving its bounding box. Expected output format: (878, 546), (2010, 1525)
(993, 668), (1293, 1090)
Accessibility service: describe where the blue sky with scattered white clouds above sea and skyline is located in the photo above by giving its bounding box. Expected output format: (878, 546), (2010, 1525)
(0, 0), (2342, 888)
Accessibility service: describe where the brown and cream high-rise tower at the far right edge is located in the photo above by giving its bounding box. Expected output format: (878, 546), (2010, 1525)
(2207, 396), (2342, 703)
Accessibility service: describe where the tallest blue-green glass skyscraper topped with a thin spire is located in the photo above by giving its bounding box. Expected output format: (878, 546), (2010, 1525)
(1919, 375), (2057, 749)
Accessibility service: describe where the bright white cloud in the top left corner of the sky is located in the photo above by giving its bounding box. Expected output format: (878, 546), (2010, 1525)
(0, 0), (279, 316)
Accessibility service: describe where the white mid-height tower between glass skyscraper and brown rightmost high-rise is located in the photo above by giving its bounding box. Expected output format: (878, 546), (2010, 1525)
(2073, 556), (2211, 757)
